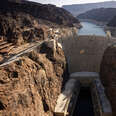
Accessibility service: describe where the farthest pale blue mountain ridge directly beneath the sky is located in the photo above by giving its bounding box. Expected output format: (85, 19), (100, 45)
(62, 1), (116, 16)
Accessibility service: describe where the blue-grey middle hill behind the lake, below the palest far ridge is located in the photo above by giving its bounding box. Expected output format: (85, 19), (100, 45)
(77, 8), (116, 23)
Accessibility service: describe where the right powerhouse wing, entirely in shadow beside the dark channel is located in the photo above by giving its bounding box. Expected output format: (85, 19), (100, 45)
(91, 79), (112, 116)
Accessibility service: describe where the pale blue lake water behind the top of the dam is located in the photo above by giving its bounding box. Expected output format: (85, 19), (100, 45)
(78, 22), (106, 36)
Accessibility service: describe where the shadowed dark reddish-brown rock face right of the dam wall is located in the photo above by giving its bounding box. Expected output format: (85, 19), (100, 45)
(100, 45), (116, 116)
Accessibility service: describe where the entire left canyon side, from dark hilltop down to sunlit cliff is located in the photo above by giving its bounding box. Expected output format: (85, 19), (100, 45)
(0, 0), (79, 116)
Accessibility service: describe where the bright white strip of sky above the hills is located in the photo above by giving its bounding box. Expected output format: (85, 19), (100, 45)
(29, 0), (116, 7)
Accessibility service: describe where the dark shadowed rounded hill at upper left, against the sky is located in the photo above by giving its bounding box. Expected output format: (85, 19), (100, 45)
(0, 0), (79, 27)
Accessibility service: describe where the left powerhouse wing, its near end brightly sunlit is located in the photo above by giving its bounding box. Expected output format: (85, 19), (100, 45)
(54, 79), (80, 116)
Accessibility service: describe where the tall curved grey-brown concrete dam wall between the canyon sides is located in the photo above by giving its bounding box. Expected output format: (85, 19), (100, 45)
(60, 36), (116, 73)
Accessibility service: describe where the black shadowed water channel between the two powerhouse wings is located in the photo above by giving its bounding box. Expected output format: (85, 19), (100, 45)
(73, 87), (94, 116)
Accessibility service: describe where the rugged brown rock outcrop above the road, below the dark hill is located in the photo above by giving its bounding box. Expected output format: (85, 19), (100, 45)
(0, 12), (48, 45)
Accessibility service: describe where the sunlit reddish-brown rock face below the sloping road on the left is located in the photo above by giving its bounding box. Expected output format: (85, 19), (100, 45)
(0, 45), (66, 116)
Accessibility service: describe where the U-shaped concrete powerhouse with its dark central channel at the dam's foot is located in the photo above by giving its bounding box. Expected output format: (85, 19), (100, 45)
(55, 72), (112, 116)
